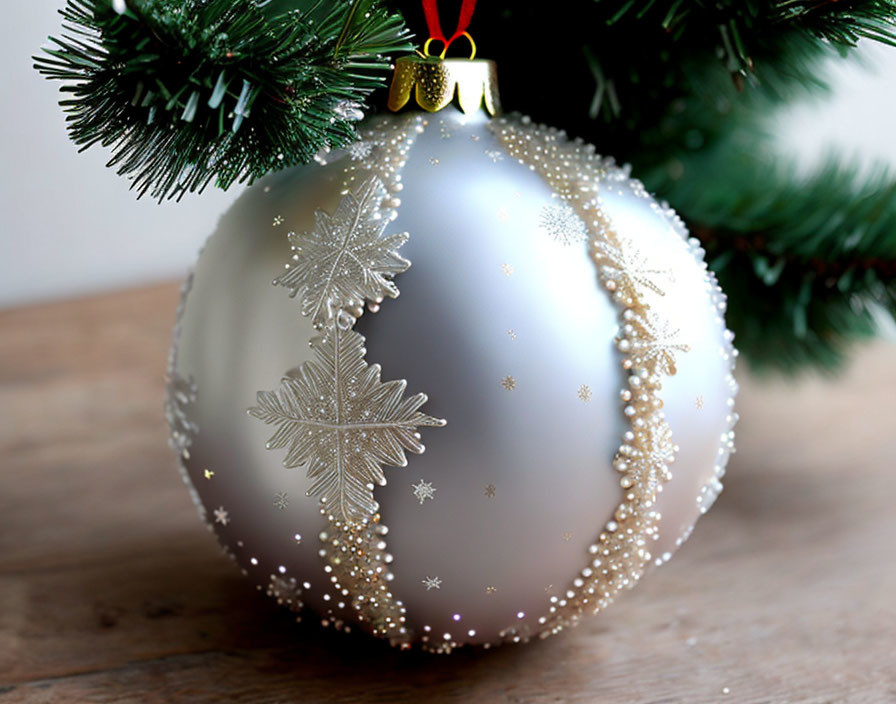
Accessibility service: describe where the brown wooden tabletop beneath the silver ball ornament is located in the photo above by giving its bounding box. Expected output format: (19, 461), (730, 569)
(0, 285), (896, 704)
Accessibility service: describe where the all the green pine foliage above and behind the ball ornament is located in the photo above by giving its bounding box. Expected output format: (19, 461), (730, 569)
(36, 0), (896, 370)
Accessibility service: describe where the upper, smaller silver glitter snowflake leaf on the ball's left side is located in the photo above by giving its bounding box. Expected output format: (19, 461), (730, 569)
(274, 174), (411, 329)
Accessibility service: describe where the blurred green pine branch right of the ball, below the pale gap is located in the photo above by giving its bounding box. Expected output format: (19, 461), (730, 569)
(652, 140), (896, 371)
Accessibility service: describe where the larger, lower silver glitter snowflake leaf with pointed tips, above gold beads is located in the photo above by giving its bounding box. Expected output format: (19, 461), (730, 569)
(249, 325), (445, 524)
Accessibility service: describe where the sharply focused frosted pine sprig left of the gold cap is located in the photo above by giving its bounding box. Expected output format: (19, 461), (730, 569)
(35, 0), (411, 200)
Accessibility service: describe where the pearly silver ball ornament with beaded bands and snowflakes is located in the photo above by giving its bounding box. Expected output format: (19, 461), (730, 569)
(166, 60), (736, 652)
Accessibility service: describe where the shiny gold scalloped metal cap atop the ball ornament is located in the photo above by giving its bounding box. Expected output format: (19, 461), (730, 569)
(387, 55), (501, 115)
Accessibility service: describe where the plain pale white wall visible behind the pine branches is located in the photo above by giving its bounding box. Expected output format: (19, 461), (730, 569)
(0, 0), (896, 307)
